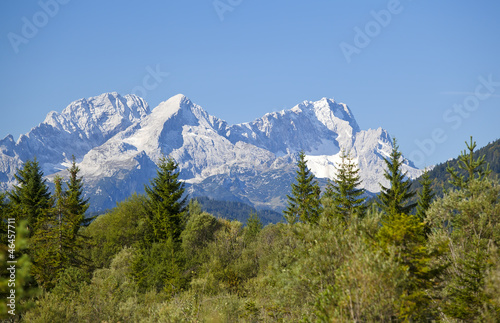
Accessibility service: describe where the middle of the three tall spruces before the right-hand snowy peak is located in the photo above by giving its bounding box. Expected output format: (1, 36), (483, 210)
(325, 150), (366, 221)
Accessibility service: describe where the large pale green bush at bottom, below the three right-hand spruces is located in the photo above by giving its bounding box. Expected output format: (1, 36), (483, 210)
(315, 225), (406, 322)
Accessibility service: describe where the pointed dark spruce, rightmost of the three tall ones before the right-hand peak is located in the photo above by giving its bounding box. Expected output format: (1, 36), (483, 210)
(377, 138), (416, 215)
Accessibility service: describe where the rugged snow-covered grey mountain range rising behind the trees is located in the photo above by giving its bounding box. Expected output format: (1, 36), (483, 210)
(0, 92), (421, 212)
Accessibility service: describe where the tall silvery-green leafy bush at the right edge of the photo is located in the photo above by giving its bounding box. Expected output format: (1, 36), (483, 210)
(428, 178), (500, 321)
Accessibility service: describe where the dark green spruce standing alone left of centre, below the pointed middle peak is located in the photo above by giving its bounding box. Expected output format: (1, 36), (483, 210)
(145, 156), (187, 243)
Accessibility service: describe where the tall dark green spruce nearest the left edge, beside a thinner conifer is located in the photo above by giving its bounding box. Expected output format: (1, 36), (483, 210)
(9, 158), (51, 237)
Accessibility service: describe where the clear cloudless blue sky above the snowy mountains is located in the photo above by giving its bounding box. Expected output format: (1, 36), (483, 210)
(0, 0), (500, 167)
